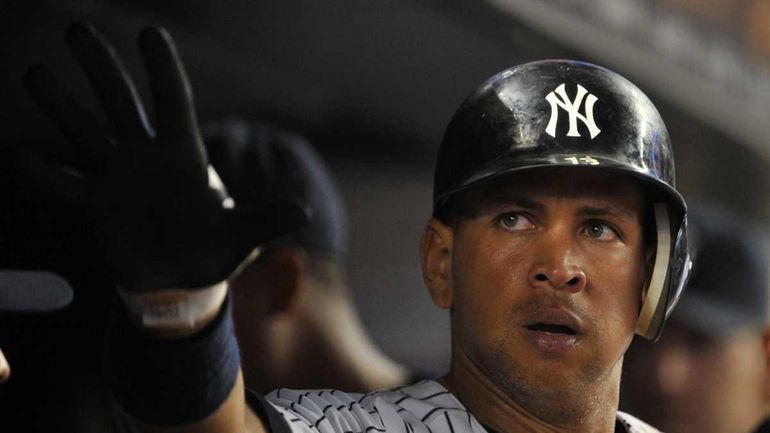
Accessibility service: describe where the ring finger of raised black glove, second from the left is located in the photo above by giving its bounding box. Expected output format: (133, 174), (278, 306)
(23, 65), (111, 171)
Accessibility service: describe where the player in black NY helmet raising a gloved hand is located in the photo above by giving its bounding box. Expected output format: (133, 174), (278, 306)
(26, 25), (689, 433)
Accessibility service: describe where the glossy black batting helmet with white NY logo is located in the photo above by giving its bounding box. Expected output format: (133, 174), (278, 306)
(433, 60), (691, 340)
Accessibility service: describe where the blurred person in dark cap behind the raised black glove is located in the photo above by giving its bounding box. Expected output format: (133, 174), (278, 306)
(203, 118), (412, 393)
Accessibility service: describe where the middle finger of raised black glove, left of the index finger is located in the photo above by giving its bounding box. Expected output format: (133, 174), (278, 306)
(67, 23), (152, 140)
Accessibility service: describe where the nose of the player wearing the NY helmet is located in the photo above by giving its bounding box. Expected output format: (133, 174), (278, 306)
(528, 231), (586, 293)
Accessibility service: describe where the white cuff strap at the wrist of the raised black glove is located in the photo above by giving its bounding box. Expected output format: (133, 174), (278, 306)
(118, 281), (227, 330)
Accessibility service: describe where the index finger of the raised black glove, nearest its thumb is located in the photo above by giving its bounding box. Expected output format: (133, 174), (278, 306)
(139, 27), (201, 151)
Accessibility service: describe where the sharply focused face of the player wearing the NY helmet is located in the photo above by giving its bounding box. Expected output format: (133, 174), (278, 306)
(432, 168), (645, 416)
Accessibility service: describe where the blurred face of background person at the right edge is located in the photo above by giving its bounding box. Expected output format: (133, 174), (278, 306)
(623, 321), (768, 433)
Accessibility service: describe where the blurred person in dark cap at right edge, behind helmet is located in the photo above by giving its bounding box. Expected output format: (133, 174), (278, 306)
(621, 204), (770, 433)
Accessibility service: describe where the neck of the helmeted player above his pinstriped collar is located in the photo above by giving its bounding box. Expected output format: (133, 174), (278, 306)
(439, 344), (620, 433)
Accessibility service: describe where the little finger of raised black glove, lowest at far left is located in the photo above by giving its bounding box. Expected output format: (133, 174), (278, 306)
(12, 149), (87, 205)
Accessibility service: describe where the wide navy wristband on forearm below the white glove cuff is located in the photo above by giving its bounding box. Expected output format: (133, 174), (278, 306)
(107, 292), (240, 426)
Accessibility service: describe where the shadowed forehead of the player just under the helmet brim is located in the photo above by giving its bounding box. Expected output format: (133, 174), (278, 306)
(464, 167), (645, 214)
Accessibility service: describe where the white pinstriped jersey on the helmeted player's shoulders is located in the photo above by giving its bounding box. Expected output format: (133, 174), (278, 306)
(265, 380), (660, 433)
